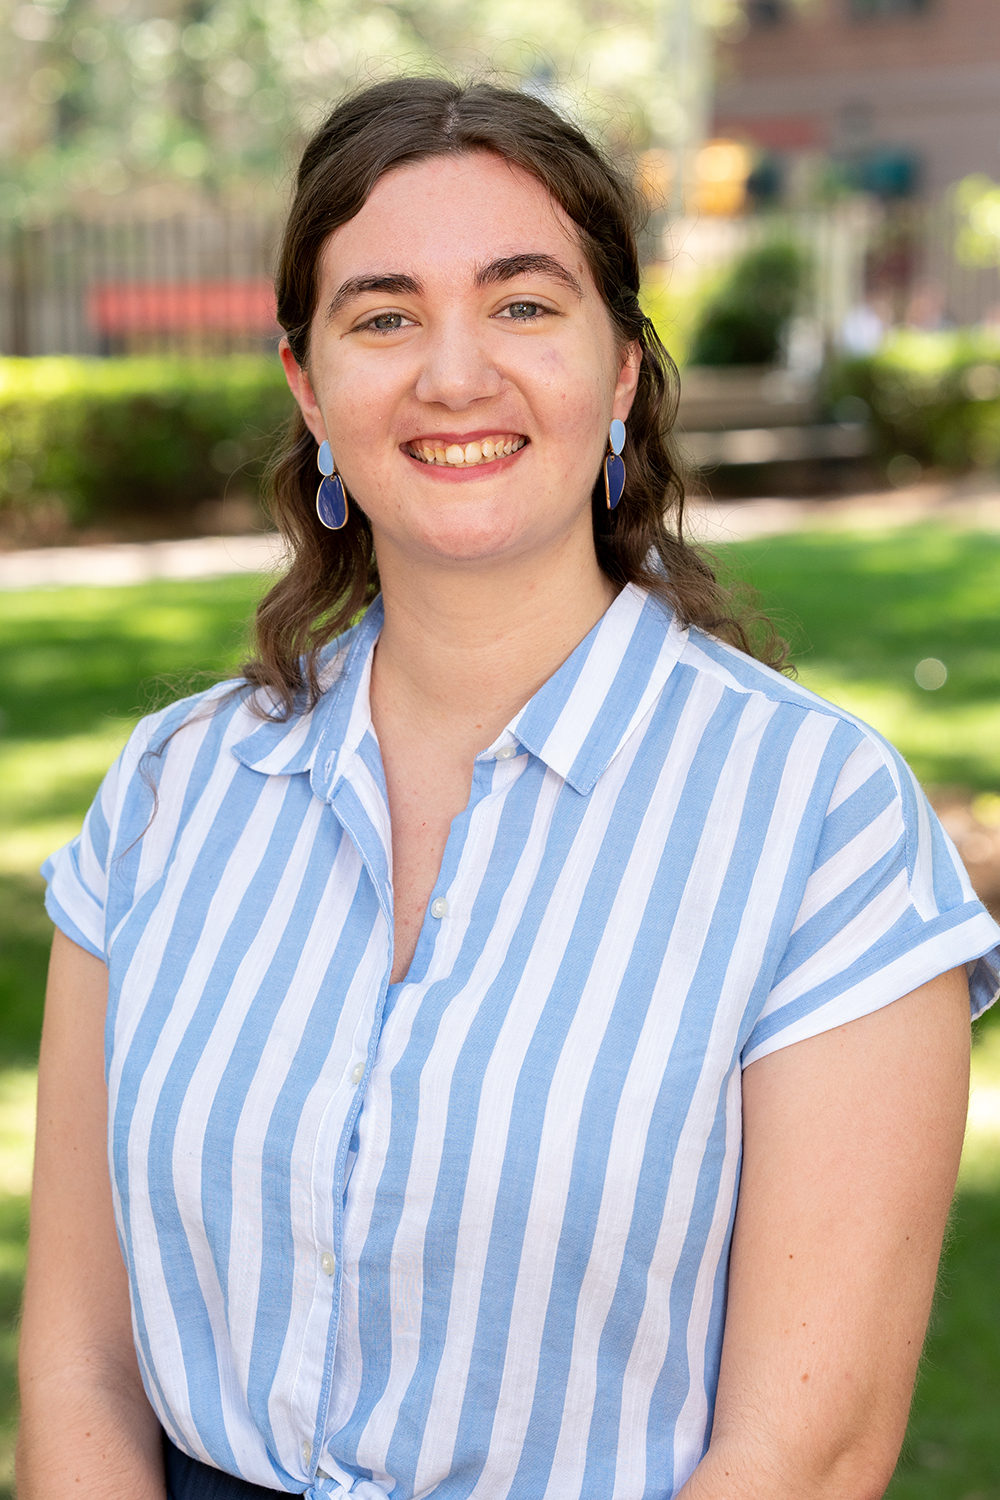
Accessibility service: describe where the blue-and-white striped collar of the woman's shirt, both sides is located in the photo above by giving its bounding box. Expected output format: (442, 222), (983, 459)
(232, 584), (687, 801)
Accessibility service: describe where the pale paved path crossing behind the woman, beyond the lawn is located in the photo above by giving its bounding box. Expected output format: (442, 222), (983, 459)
(0, 477), (1000, 591)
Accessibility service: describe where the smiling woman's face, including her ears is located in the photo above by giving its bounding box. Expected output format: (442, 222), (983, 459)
(282, 152), (639, 561)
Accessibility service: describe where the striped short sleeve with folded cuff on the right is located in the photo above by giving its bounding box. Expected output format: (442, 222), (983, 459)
(742, 732), (1000, 1065)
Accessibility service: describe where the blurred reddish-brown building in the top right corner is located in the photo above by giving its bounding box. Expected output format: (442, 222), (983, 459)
(715, 0), (1000, 204)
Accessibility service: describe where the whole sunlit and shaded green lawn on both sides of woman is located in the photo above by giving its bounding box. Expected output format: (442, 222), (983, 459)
(0, 525), (1000, 1500)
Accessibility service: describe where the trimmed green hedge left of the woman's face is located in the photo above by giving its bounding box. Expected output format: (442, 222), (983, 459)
(0, 356), (291, 527)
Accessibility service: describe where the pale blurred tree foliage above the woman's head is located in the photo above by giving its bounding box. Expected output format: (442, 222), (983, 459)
(0, 0), (739, 218)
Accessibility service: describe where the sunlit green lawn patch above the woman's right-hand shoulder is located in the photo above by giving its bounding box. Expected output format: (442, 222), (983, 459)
(717, 525), (1000, 792)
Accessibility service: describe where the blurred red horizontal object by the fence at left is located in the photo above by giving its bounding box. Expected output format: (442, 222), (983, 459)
(87, 276), (277, 336)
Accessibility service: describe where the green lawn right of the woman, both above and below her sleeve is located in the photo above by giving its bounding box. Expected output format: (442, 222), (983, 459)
(728, 525), (1000, 1500)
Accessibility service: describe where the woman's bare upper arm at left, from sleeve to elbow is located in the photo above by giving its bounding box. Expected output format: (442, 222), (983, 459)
(22, 932), (138, 1379)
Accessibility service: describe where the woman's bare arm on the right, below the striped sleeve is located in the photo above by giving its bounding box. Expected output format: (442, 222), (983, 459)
(679, 971), (969, 1500)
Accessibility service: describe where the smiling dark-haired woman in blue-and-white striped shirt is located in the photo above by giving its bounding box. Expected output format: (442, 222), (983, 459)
(19, 80), (997, 1500)
